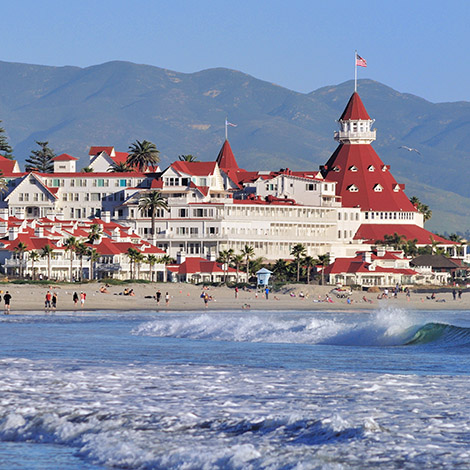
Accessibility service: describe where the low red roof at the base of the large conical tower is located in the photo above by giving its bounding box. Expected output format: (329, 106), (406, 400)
(354, 224), (456, 245)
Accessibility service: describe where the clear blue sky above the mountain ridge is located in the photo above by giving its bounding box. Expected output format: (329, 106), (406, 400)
(4, 0), (470, 102)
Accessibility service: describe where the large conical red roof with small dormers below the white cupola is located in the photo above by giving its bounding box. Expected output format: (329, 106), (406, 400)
(323, 144), (416, 212)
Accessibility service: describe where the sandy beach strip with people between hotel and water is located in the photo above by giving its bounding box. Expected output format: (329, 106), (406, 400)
(0, 283), (470, 314)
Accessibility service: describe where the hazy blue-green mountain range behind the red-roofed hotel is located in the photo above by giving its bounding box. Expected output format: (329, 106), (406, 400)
(0, 61), (470, 234)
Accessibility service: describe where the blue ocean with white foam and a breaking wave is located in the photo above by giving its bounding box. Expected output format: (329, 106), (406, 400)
(0, 308), (470, 470)
